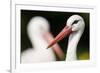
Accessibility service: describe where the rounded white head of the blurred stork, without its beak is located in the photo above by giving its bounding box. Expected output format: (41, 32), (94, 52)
(27, 16), (49, 36)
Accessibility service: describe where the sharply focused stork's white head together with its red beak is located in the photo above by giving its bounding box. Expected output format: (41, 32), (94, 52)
(47, 15), (85, 48)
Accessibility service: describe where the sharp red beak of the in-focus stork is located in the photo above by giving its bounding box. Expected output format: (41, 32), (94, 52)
(47, 26), (72, 48)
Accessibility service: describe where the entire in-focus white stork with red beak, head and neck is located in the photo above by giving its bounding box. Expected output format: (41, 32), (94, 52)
(47, 15), (85, 61)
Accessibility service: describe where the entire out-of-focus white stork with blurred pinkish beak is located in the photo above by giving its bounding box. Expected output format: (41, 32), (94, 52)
(21, 16), (64, 63)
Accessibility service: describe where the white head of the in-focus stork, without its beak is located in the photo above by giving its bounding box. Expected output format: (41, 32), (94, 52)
(66, 15), (85, 31)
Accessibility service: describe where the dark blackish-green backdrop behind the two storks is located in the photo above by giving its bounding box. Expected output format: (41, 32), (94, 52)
(21, 10), (90, 60)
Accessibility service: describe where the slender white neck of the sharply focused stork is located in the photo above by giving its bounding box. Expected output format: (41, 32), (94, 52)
(66, 31), (82, 61)
